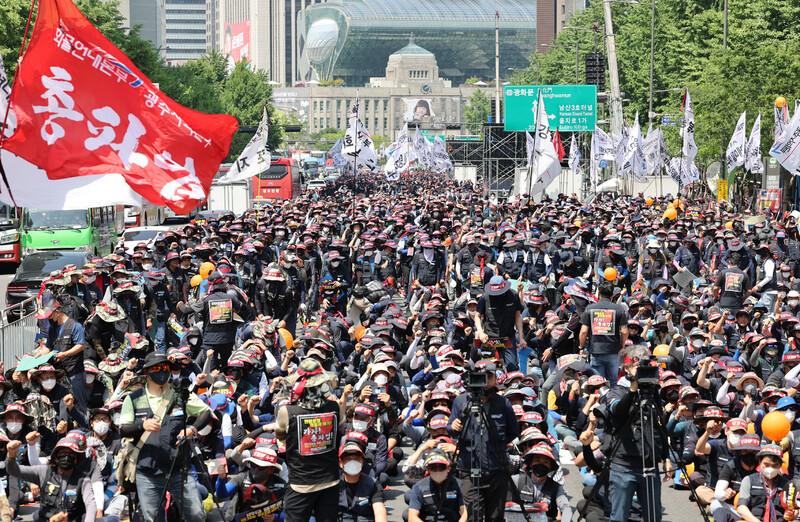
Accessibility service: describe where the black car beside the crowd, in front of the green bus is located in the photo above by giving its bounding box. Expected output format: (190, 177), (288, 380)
(6, 250), (91, 321)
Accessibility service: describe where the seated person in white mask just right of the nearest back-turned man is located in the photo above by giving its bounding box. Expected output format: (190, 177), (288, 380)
(339, 442), (388, 522)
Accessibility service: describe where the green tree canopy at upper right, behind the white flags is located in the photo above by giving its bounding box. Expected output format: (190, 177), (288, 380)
(509, 0), (800, 168)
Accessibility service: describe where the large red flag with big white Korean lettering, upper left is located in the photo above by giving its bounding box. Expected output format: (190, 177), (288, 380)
(3, 0), (238, 213)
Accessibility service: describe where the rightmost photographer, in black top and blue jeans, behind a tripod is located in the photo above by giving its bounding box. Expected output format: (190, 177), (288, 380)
(608, 346), (667, 522)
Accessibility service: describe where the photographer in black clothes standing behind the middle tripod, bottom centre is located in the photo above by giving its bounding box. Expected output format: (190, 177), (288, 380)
(448, 360), (519, 521)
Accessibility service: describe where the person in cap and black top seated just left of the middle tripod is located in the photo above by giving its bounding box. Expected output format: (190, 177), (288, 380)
(408, 450), (466, 522)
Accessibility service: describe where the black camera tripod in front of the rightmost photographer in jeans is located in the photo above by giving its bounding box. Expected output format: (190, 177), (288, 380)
(578, 383), (710, 522)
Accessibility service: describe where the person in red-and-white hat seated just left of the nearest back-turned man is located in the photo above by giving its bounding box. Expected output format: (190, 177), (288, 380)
(215, 447), (287, 520)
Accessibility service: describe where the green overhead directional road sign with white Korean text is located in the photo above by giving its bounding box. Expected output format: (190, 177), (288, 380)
(503, 85), (597, 132)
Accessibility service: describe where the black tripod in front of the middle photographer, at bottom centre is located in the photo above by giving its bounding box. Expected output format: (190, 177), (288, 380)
(434, 388), (531, 522)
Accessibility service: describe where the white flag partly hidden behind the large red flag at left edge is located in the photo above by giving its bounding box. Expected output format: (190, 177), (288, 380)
(0, 50), (142, 210)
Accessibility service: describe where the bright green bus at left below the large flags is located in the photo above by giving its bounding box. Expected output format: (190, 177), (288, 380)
(20, 205), (125, 257)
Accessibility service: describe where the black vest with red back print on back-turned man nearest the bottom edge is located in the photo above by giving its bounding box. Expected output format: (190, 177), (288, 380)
(286, 401), (339, 485)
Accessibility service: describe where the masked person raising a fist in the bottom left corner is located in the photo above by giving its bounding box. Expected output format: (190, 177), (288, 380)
(6, 437), (115, 522)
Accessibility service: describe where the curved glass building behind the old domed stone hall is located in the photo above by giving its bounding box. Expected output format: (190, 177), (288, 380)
(297, 0), (536, 86)
